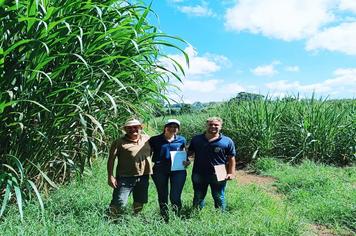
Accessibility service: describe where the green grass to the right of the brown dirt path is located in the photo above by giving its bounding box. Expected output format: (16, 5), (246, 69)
(255, 159), (356, 232)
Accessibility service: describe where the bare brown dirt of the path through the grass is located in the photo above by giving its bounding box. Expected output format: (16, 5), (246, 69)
(236, 170), (337, 236)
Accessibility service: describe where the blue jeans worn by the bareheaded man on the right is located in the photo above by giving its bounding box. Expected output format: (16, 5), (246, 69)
(192, 173), (226, 211)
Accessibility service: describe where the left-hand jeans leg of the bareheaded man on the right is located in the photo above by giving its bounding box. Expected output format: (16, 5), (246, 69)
(192, 173), (208, 209)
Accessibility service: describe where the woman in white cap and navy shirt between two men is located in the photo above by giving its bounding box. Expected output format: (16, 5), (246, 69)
(149, 119), (187, 221)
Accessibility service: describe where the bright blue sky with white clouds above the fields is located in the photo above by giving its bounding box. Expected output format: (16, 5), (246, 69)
(147, 0), (356, 103)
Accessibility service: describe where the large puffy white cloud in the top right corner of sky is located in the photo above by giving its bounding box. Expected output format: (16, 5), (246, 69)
(225, 0), (356, 55)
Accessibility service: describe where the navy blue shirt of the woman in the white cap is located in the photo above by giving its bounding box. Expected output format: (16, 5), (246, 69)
(148, 134), (187, 171)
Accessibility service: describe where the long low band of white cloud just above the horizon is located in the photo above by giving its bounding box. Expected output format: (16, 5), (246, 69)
(171, 68), (356, 103)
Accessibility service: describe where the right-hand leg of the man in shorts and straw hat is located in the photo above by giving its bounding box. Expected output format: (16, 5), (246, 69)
(132, 175), (149, 214)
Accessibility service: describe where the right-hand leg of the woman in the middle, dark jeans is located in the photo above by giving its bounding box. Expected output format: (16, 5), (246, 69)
(169, 170), (187, 213)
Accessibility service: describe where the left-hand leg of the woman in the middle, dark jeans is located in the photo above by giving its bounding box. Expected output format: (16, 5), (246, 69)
(152, 172), (169, 217)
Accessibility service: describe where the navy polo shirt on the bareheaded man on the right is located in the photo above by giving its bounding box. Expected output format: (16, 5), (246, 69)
(188, 134), (236, 175)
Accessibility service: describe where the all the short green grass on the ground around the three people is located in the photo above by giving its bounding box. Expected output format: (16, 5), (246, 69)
(0, 159), (356, 235)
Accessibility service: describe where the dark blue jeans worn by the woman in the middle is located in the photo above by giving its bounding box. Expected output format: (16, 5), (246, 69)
(152, 170), (187, 216)
